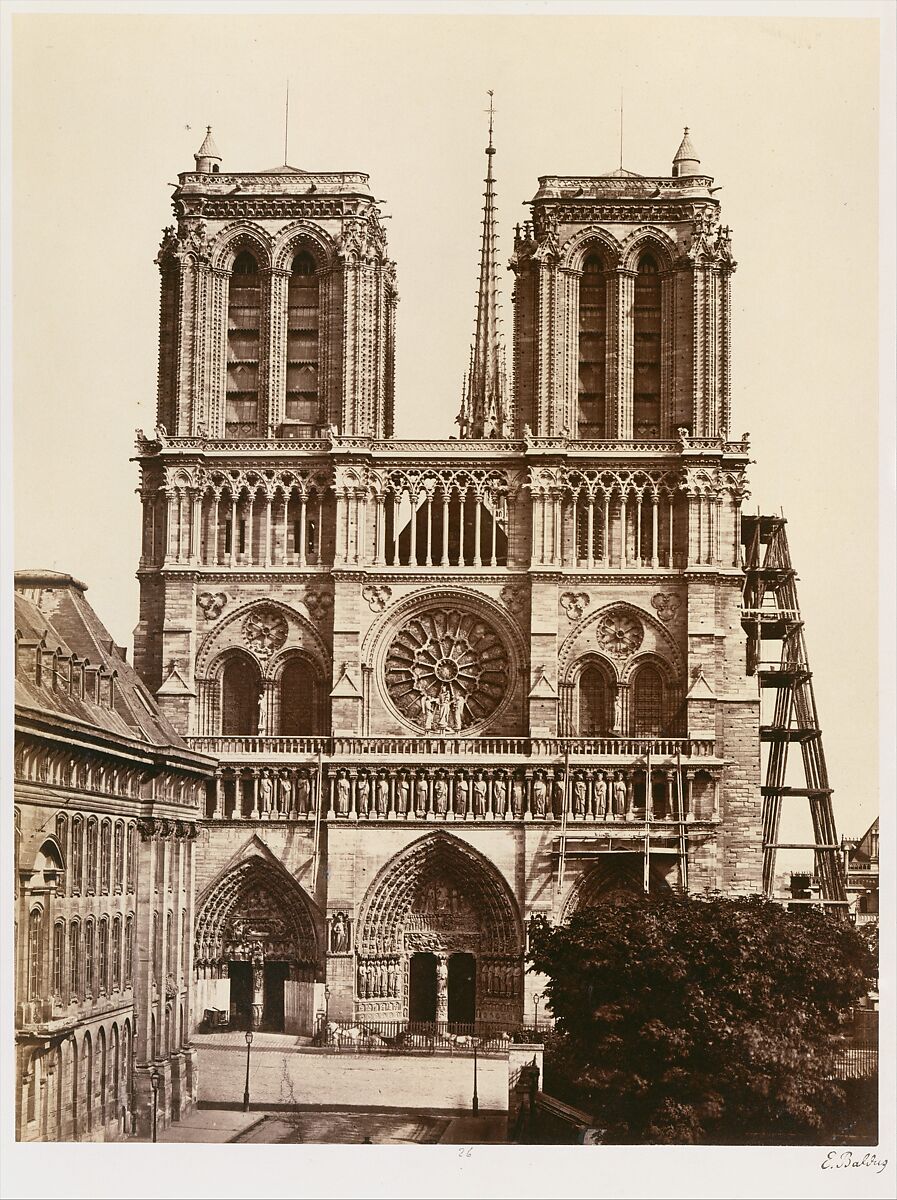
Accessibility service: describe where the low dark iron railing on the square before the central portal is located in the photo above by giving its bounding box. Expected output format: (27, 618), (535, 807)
(314, 1021), (519, 1056)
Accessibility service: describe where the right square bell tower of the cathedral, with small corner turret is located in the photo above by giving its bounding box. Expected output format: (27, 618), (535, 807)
(512, 128), (735, 442)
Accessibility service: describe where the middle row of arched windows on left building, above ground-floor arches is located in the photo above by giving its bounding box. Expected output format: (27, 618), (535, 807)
(28, 906), (134, 1003)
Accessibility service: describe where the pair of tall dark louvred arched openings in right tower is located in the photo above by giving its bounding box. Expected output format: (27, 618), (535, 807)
(577, 252), (662, 438)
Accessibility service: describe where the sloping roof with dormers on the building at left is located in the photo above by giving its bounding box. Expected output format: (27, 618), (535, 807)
(16, 571), (188, 750)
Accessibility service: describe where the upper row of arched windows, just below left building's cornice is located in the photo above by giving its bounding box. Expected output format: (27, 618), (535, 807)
(56, 812), (137, 895)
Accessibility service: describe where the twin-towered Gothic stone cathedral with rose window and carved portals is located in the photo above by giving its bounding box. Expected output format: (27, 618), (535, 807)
(136, 130), (761, 1033)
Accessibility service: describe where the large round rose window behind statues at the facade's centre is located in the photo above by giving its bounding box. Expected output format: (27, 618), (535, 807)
(385, 608), (508, 733)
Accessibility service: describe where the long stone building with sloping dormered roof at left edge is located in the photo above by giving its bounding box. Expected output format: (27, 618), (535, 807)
(14, 571), (212, 1141)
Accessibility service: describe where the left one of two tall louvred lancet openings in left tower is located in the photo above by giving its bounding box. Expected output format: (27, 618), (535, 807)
(224, 250), (261, 437)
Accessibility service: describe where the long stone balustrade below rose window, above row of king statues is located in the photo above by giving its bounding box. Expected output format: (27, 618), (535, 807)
(187, 733), (716, 761)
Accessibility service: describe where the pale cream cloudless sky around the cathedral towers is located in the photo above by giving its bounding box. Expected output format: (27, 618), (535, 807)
(12, 12), (879, 849)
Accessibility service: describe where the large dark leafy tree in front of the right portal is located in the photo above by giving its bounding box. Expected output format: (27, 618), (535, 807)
(530, 893), (874, 1144)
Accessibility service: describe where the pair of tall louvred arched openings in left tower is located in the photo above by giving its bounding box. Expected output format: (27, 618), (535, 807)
(224, 250), (321, 438)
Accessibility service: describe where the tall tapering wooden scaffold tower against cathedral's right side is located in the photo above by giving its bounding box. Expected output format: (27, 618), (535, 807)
(741, 515), (847, 913)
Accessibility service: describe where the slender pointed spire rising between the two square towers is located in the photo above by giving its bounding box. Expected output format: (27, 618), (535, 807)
(458, 92), (511, 438)
